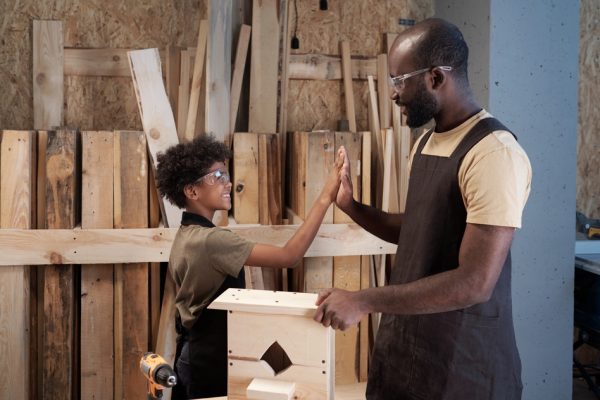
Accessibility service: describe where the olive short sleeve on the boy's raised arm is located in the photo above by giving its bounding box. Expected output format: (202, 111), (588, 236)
(206, 229), (255, 276)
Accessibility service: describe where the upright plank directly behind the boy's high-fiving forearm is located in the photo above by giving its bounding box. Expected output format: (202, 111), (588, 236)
(302, 131), (335, 293)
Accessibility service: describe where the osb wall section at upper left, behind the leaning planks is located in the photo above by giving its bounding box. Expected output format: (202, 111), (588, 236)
(0, 0), (207, 130)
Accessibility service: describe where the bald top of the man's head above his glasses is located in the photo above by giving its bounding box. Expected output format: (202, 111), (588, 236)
(390, 18), (469, 83)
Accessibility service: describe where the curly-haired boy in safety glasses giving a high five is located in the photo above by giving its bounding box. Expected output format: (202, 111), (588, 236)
(156, 135), (347, 399)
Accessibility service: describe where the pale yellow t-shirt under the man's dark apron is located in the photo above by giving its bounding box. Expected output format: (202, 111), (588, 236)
(409, 110), (531, 228)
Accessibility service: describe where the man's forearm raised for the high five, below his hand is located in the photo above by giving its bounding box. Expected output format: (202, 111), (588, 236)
(343, 201), (402, 244)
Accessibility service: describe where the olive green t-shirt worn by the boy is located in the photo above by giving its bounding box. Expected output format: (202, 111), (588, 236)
(169, 225), (254, 329)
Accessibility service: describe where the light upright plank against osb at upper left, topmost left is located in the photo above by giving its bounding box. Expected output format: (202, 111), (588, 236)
(33, 21), (64, 129)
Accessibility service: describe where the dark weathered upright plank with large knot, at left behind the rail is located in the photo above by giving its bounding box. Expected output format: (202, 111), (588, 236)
(40, 130), (79, 399)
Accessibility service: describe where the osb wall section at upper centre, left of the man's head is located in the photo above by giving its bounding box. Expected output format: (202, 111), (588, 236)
(287, 0), (434, 131)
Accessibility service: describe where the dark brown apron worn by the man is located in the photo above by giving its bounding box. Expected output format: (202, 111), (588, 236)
(367, 118), (522, 400)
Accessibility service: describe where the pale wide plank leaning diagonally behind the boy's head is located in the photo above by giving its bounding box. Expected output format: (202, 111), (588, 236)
(127, 49), (181, 228)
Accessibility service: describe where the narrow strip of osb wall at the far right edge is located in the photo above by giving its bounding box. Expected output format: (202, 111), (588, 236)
(577, 0), (600, 218)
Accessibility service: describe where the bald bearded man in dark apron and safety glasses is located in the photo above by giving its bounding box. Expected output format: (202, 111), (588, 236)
(315, 19), (531, 400)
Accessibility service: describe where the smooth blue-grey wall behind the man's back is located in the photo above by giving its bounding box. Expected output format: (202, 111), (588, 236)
(435, 0), (579, 400)
